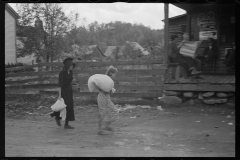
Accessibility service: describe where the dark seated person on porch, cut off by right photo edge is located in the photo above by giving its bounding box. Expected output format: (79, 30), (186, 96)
(225, 42), (236, 72)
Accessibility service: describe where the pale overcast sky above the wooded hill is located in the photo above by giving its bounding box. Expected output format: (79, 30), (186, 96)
(9, 2), (186, 29)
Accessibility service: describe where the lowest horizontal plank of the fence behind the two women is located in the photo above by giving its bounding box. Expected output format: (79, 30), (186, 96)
(40, 90), (162, 98)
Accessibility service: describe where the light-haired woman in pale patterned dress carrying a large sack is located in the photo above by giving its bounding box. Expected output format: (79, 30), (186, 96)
(89, 66), (118, 135)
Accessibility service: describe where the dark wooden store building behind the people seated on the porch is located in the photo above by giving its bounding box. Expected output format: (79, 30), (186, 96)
(169, 3), (236, 74)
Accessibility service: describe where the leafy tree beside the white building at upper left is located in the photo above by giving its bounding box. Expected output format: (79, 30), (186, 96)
(17, 3), (78, 62)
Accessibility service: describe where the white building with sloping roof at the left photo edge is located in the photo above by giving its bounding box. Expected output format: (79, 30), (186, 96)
(5, 4), (20, 64)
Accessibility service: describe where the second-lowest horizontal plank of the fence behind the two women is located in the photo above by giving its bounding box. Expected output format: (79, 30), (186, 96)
(6, 83), (163, 91)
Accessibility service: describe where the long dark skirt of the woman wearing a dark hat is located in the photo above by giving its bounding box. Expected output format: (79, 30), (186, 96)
(54, 84), (75, 121)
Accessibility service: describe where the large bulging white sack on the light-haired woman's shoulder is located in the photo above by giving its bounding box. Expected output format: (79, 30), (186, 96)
(88, 74), (114, 92)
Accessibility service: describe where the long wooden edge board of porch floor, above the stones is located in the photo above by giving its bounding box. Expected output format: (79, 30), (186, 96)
(163, 84), (235, 92)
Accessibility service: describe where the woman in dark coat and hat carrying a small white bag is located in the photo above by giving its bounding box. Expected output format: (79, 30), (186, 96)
(51, 58), (75, 129)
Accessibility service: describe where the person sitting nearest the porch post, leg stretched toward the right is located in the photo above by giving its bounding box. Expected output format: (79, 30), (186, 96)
(168, 35), (200, 75)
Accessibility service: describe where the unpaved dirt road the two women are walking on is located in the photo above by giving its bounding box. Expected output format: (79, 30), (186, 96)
(5, 99), (235, 157)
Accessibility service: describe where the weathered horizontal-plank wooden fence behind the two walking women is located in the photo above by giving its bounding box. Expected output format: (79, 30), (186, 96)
(5, 59), (166, 98)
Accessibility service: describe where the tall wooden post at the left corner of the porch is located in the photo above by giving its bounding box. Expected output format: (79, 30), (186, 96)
(164, 3), (169, 65)
